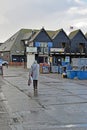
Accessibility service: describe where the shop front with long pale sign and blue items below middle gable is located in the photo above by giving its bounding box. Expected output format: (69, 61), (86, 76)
(50, 48), (71, 73)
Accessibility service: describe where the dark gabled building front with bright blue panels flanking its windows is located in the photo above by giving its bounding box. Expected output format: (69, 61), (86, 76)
(29, 28), (53, 63)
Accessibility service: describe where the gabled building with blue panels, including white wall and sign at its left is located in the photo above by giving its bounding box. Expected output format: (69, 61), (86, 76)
(24, 28), (53, 68)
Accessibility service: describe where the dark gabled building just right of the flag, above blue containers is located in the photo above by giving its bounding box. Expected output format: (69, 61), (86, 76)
(69, 29), (87, 59)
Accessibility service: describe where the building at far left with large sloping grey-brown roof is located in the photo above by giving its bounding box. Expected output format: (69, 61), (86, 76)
(0, 29), (32, 62)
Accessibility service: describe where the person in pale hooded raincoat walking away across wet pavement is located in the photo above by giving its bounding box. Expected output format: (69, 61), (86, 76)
(30, 61), (39, 91)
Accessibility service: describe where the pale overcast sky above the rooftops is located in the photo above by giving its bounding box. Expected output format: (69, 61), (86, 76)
(0, 0), (87, 42)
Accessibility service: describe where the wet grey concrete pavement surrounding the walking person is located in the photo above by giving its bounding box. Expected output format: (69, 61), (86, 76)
(0, 67), (87, 130)
